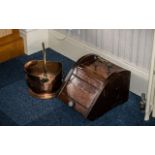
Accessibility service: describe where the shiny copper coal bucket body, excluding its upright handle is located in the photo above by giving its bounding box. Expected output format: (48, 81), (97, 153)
(24, 60), (62, 99)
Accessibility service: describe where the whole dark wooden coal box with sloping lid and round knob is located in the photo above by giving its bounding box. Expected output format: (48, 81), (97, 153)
(58, 54), (131, 120)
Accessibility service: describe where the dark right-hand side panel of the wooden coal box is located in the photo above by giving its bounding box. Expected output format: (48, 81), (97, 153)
(88, 71), (131, 120)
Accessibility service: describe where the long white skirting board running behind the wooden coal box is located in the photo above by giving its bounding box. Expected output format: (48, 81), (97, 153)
(48, 30), (148, 95)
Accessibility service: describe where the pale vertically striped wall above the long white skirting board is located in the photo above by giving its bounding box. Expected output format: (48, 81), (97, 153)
(59, 29), (153, 72)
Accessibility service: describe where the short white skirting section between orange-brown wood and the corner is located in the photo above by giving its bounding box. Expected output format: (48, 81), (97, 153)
(20, 29), (49, 55)
